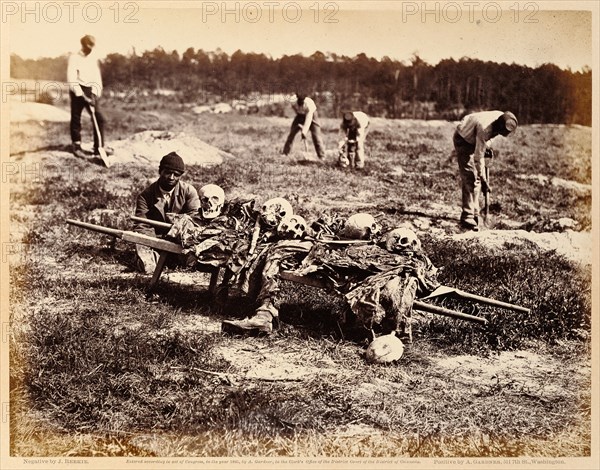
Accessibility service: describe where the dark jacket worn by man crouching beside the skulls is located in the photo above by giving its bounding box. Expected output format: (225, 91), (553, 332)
(134, 180), (200, 235)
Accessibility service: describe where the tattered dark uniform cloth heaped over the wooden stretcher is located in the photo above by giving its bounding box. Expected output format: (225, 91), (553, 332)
(169, 204), (439, 334)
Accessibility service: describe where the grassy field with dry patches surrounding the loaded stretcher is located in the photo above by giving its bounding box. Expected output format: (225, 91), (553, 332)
(5, 100), (592, 458)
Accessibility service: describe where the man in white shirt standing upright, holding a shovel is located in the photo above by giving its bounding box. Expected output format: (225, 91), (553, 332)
(67, 34), (112, 158)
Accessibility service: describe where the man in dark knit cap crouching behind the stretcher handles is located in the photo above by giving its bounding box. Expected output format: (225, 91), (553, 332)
(133, 152), (200, 274)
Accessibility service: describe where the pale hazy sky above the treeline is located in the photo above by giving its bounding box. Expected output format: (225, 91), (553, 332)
(2, 0), (598, 70)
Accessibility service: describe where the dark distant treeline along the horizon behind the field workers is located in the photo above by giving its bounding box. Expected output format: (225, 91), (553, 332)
(11, 48), (592, 126)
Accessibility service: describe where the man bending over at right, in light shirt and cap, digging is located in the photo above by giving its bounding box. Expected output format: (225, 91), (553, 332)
(453, 111), (518, 230)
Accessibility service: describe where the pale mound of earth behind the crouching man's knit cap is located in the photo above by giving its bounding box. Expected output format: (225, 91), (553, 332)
(108, 130), (233, 166)
